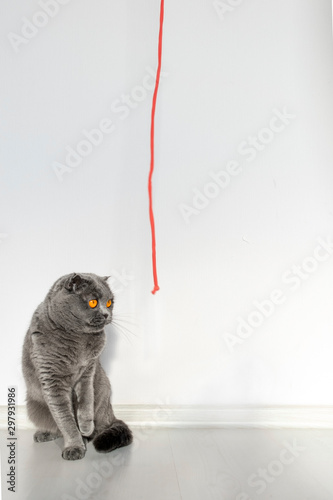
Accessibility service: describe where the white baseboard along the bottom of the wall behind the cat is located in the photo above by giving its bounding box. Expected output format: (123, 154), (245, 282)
(0, 405), (333, 429)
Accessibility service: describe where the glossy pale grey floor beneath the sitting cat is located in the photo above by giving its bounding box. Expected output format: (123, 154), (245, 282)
(1, 428), (333, 500)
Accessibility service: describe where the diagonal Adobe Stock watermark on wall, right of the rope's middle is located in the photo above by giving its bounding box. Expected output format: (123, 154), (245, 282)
(178, 106), (296, 224)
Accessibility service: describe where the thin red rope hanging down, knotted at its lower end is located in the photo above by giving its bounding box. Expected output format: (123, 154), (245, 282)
(148, 0), (164, 294)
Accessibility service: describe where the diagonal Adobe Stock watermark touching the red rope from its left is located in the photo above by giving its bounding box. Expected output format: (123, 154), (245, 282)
(52, 66), (168, 182)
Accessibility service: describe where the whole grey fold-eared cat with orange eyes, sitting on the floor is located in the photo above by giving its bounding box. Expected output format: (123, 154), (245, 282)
(22, 273), (133, 460)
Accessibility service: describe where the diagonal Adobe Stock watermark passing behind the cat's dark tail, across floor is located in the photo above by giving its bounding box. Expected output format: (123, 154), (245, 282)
(60, 398), (171, 500)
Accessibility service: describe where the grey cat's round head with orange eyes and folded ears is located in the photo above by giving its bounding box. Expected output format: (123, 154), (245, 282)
(46, 273), (114, 333)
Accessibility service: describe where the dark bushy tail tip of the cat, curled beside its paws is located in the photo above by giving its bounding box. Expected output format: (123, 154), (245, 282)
(93, 419), (133, 453)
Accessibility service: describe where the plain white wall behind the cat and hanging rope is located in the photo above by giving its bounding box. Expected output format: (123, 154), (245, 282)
(0, 0), (333, 405)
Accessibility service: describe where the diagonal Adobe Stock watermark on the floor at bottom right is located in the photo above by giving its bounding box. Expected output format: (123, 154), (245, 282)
(235, 439), (306, 500)
